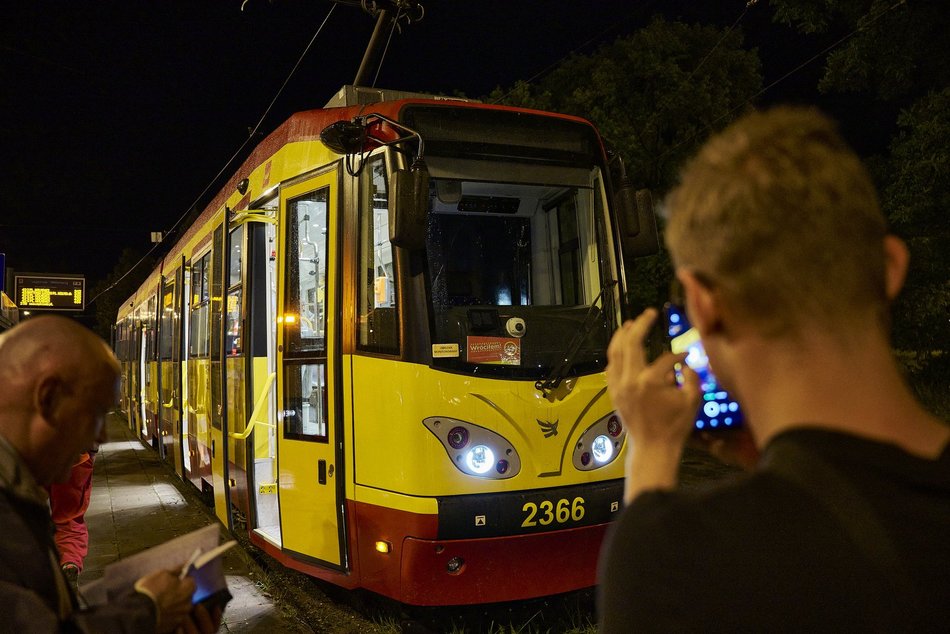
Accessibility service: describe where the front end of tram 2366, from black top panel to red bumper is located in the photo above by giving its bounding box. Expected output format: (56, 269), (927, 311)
(334, 102), (656, 605)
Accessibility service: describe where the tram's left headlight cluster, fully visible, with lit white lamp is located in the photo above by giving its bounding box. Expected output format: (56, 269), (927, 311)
(422, 416), (521, 479)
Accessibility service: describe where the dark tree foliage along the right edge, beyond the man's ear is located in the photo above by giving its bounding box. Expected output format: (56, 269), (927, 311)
(771, 0), (950, 418)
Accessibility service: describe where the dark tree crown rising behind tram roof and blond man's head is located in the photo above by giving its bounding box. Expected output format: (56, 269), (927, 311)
(489, 18), (762, 310)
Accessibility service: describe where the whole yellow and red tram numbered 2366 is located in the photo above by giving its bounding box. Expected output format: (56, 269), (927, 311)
(115, 86), (656, 606)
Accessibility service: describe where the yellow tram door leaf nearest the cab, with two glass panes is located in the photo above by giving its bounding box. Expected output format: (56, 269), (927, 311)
(277, 170), (345, 567)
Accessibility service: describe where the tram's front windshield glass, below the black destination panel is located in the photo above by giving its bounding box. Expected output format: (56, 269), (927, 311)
(426, 165), (615, 378)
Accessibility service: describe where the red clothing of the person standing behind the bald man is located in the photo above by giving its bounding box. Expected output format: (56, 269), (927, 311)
(46, 444), (99, 590)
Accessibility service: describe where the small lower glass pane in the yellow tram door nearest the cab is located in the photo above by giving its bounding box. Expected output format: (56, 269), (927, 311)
(283, 363), (328, 442)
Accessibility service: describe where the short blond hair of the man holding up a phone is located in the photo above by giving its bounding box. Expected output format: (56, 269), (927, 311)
(666, 107), (887, 335)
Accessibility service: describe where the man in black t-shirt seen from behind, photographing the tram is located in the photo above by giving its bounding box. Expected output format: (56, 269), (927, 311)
(598, 107), (950, 633)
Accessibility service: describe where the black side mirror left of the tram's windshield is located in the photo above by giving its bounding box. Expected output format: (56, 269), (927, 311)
(389, 159), (429, 251)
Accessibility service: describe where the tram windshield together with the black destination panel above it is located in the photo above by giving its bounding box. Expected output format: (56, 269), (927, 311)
(384, 105), (617, 379)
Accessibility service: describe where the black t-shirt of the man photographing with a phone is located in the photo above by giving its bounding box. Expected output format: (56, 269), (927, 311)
(598, 429), (950, 633)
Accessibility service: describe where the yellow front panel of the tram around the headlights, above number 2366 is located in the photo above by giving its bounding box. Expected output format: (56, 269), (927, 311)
(351, 356), (623, 510)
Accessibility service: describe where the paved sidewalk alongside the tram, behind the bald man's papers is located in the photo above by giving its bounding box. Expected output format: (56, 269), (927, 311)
(79, 416), (312, 633)
